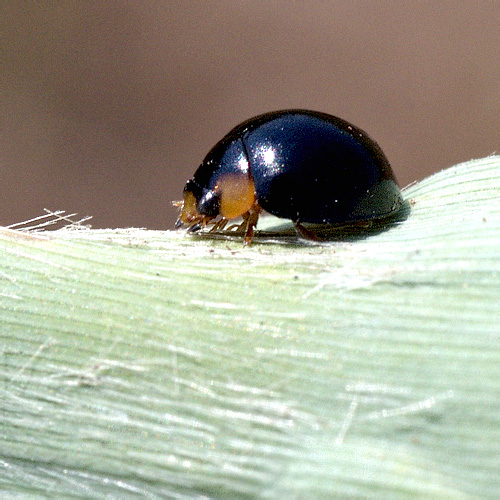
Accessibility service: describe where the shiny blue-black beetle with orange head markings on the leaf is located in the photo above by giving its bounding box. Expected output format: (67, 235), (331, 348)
(173, 109), (402, 244)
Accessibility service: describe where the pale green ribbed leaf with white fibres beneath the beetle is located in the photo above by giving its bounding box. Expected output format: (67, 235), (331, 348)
(0, 156), (500, 499)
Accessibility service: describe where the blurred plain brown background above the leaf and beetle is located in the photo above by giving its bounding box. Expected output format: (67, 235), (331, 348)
(0, 0), (500, 229)
